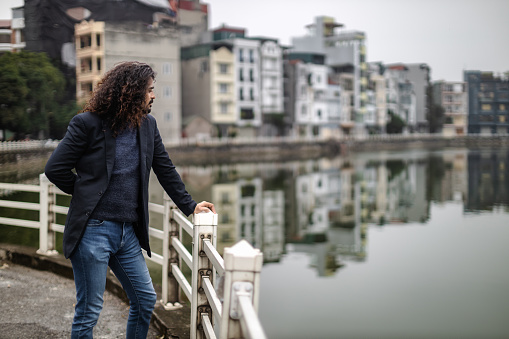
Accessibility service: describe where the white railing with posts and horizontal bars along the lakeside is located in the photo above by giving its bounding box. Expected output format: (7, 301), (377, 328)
(0, 174), (266, 339)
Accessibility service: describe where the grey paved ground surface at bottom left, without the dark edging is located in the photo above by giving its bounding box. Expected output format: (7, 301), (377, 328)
(0, 260), (161, 339)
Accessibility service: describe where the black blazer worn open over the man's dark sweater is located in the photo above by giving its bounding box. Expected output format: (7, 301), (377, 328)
(45, 112), (196, 258)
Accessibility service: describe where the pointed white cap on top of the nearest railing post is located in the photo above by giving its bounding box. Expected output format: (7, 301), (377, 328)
(224, 239), (263, 272)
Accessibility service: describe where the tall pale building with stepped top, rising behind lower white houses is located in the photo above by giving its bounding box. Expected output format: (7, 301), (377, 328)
(292, 16), (368, 134)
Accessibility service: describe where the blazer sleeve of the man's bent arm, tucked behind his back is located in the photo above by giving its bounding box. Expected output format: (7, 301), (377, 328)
(44, 114), (87, 194)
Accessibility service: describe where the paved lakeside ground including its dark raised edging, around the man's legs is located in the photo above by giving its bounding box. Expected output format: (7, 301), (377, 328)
(0, 244), (186, 339)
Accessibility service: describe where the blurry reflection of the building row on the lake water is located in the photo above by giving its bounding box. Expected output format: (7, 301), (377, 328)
(145, 150), (509, 276)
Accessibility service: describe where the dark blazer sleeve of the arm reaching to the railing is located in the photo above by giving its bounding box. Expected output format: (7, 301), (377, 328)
(152, 120), (196, 216)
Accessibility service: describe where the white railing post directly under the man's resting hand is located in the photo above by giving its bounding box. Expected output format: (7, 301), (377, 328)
(191, 212), (217, 339)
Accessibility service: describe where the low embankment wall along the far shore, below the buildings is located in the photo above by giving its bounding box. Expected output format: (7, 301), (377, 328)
(166, 135), (509, 165)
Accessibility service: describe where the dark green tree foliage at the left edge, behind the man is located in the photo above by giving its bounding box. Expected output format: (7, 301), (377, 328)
(0, 51), (76, 139)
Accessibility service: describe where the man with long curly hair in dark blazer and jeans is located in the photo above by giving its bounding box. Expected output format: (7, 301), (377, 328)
(45, 62), (215, 338)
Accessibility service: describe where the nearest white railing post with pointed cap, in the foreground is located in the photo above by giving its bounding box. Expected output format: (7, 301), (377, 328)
(220, 240), (263, 339)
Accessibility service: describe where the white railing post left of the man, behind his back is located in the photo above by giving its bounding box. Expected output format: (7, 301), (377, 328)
(37, 173), (58, 255)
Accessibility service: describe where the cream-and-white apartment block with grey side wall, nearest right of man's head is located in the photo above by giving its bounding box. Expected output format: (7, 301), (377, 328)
(182, 26), (284, 137)
